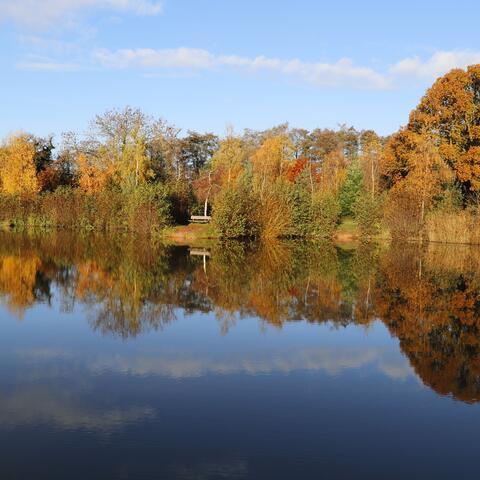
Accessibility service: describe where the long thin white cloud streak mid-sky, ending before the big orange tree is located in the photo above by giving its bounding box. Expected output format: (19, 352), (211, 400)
(94, 47), (389, 89)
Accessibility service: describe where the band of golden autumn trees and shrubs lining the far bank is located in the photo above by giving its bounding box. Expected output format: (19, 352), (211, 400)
(0, 65), (480, 243)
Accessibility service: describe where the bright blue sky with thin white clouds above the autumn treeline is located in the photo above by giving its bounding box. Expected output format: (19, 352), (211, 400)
(0, 0), (480, 141)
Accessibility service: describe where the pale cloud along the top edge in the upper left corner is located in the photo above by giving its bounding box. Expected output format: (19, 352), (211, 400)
(0, 0), (162, 25)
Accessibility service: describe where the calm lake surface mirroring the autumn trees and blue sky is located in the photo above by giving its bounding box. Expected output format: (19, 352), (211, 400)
(0, 234), (480, 479)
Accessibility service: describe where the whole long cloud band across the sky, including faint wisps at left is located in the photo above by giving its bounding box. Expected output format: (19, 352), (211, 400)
(13, 43), (480, 90)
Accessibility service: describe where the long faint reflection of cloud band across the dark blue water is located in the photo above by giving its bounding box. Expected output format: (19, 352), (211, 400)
(17, 346), (415, 380)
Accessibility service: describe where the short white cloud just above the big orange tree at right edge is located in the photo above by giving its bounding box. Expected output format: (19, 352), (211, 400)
(390, 50), (480, 79)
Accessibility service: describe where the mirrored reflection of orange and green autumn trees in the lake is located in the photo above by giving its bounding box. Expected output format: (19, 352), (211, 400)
(0, 232), (480, 402)
